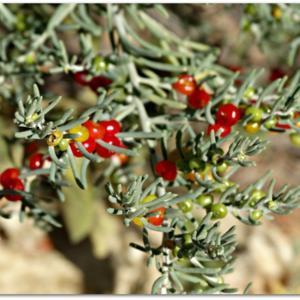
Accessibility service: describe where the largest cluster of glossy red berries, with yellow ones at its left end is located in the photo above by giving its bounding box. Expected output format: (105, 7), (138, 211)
(47, 120), (125, 159)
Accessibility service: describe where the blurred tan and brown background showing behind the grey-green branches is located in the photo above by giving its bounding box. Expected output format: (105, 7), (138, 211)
(0, 4), (300, 294)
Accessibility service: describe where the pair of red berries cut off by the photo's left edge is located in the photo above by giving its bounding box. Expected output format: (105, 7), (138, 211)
(0, 168), (24, 201)
